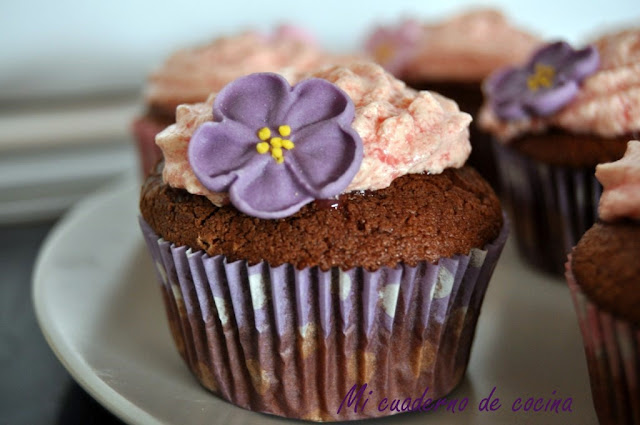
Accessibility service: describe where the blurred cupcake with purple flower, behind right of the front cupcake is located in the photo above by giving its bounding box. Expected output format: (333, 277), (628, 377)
(479, 30), (640, 275)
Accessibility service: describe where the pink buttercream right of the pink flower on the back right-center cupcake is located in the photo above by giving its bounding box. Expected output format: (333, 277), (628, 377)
(390, 9), (540, 82)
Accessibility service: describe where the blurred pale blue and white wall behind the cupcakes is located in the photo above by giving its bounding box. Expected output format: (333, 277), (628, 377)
(0, 0), (640, 223)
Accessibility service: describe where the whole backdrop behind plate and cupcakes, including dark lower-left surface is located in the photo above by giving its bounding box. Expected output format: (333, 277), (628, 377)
(0, 0), (640, 425)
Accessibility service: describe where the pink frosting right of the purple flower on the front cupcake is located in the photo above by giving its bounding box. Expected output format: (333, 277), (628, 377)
(311, 63), (471, 191)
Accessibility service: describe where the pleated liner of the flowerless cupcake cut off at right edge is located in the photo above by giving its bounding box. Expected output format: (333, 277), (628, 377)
(566, 255), (640, 425)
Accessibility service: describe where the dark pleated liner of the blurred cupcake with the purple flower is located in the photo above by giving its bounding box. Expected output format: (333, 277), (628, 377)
(493, 140), (602, 276)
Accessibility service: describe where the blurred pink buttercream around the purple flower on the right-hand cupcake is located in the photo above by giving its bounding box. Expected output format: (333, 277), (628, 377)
(479, 30), (640, 143)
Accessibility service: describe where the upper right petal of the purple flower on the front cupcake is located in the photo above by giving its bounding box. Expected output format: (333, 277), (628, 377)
(277, 78), (355, 128)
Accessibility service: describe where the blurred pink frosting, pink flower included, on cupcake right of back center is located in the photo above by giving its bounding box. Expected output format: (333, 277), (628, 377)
(367, 9), (540, 81)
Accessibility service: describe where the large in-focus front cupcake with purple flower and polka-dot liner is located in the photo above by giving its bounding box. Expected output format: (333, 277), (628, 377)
(140, 62), (507, 421)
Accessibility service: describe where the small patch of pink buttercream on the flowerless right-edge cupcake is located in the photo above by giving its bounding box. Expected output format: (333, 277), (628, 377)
(596, 140), (640, 221)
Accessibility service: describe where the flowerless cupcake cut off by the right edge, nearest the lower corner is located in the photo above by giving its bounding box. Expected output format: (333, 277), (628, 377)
(566, 141), (640, 425)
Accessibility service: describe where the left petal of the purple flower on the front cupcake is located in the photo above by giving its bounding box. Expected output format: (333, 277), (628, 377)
(188, 120), (273, 192)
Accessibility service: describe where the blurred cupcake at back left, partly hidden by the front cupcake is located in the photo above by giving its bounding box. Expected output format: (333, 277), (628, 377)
(133, 25), (349, 175)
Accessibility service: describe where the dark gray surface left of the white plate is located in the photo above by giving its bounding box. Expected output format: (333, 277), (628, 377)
(0, 221), (122, 425)
